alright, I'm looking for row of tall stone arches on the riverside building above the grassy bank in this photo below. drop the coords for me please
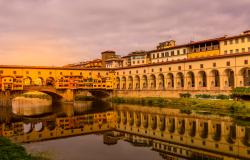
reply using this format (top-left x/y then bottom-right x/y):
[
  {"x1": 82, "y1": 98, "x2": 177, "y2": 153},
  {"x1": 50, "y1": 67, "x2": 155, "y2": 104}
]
[{"x1": 116, "y1": 68, "x2": 250, "y2": 90}]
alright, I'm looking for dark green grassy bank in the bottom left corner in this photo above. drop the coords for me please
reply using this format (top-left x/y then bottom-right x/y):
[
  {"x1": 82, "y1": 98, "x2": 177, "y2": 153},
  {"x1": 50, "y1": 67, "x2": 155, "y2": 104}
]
[{"x1": 0, "y1": 136, "x2": 50, "y2": 160}]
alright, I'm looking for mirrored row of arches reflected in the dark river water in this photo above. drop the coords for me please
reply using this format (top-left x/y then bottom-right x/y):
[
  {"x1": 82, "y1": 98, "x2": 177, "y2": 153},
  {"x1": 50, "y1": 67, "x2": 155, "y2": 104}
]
[{"x1": 116, "y1": 111, "x2": 250, "y2": 144}]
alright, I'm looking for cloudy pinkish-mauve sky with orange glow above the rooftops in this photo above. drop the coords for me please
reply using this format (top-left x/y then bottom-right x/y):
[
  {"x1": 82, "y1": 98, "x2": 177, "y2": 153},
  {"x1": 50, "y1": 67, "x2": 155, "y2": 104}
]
[{"x1": 0, "y1": 0, "x2": 250, "y2": 66}]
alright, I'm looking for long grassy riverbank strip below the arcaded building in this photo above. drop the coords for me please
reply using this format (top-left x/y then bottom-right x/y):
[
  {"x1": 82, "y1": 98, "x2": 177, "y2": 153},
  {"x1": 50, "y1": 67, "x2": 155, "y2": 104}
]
[{"x1": 109, "y1": 97, "x2": 250, "y2": 118}]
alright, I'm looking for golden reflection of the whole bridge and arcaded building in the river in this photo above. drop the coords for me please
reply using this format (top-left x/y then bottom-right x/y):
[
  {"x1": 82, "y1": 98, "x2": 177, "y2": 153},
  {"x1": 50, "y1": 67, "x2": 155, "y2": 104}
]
[{"x1": 0, "y1": 102, "x2": 250, "y2": 159}]
